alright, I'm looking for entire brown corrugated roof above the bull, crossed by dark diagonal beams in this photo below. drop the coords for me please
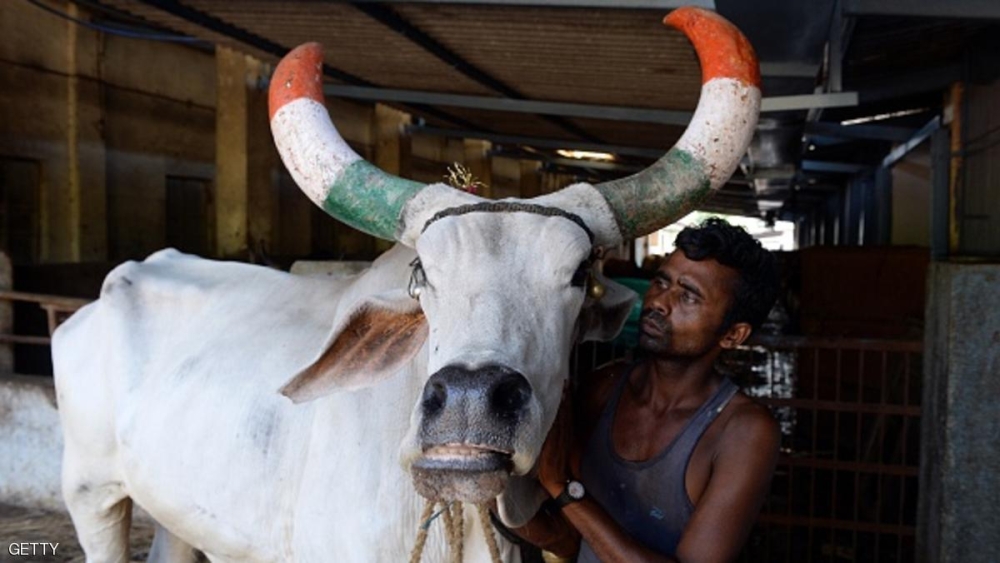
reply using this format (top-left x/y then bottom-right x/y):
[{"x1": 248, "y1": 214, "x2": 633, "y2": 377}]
[{"x1": 97, "y1": 0, "x2": 701, "y2": 138}]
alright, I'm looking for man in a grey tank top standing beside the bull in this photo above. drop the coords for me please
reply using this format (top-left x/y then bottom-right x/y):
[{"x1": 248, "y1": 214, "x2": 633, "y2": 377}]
[{"x1": 520, "y1": 219, "x2": 778, "y2": 562}]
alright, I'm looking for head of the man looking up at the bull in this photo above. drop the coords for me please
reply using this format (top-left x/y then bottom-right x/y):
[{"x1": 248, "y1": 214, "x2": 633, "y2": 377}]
[{"x1": 639, "y1": 218, "x2": 778, "y2": 357}]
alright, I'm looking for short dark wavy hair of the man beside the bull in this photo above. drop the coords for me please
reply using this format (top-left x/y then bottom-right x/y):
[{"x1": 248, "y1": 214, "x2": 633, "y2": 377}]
[{"x1": 677, "y1": 217, "x2": 778, "y2": 330}]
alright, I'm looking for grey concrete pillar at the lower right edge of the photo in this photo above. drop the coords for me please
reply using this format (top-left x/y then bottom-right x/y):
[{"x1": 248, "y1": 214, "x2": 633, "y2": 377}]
[{"x1": 916, "y1": 263, "x2": 1000, "y2": 563}]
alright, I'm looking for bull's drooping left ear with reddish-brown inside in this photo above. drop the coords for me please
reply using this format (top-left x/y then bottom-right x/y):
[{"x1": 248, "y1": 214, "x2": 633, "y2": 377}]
[{"x1": 281, "y1": 291, "x2": 427, "y2": 403}]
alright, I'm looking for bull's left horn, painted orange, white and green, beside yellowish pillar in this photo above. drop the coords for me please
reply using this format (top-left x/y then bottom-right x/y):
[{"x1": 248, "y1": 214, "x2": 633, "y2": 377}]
[{"x1": 268, "y1": 43, "x2": 424, "y2": 240}]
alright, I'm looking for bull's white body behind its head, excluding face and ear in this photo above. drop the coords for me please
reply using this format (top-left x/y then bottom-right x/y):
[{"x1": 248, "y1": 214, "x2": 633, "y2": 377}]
[{"x1": 49, "y1": 249, "x2": 524, "y2": 562}]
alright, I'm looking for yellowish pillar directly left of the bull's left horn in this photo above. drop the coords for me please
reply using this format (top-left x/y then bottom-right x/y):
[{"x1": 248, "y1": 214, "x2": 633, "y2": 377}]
[{"x1": 215, "y1": 46, "x2": 277, "y2": 258}]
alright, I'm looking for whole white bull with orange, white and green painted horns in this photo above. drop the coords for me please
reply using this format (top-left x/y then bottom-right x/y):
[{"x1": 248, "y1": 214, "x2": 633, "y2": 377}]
[{"x1": 53, "y1": 9, "x2": 760, "y2": 562}]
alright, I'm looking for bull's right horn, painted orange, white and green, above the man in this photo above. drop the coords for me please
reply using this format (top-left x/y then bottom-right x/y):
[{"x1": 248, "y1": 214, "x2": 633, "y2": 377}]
[{"x1": 594, "y1": 7, "x2": 760, "y2": 239}]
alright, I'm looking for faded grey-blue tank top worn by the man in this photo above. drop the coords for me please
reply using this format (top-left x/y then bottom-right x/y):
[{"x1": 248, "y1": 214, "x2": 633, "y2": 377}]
[{"x1": 577, "y1": 371, "x2": 739, "y2": 563}]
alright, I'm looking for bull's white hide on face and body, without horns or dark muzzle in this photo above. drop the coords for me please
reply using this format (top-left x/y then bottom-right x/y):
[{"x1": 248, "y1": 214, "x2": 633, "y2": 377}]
[{"x1": 53, "y1": 208, "x2": 634, "y2": 562}]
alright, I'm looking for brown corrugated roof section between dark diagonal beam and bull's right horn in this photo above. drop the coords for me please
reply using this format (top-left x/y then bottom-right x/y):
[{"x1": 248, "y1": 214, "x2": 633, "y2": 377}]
[{"x1": 395, "y1": 4, "x2": 701, "y2": 110}]
